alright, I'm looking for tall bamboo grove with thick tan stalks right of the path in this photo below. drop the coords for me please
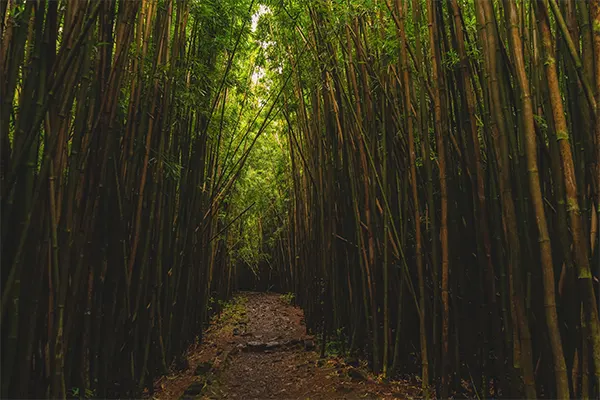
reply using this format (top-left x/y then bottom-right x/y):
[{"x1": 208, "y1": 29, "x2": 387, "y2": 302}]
[{"x1": 264, "y1": 0, "x2": 600, "y2": 398}]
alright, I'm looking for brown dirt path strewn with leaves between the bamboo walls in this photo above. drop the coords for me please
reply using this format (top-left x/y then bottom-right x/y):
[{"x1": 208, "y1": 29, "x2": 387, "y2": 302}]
[{"x1": 148, "y1": 292, "x2": 421, "y2": 400}]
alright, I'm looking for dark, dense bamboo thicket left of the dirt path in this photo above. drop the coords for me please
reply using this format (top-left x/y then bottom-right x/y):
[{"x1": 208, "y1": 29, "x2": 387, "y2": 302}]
[{"x1": 0, "y1": 0, "x2": 262, "y2": 398}]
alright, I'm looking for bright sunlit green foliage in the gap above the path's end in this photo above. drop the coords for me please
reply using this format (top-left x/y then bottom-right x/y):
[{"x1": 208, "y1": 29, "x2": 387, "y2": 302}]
[{"x1": 219, "y1": 5, "x2": 290, "y2": 275}]
